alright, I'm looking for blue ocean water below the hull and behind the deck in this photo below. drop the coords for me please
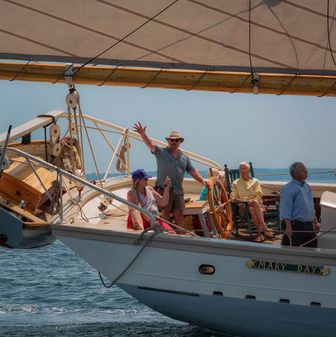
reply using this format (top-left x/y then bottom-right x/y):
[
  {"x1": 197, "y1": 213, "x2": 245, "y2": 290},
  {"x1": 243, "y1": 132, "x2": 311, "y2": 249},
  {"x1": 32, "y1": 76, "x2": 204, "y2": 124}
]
[{"x1": 0, "y1": 169, "x2": 336, "y2": 337}]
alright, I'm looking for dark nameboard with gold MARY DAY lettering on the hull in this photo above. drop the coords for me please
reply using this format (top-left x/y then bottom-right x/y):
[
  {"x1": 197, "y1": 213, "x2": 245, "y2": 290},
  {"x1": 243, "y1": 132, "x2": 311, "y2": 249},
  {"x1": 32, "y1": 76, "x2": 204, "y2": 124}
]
[{"x1": 246, "y1": 259, "x2": 330, "y2": 276}]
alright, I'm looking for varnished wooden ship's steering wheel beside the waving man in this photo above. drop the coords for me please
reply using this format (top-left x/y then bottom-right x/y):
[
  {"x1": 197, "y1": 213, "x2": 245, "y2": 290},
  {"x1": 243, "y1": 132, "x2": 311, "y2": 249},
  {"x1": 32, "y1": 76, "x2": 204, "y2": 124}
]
[{"x1": 208, "y1": 177, "x2": 232, "y2": 239}]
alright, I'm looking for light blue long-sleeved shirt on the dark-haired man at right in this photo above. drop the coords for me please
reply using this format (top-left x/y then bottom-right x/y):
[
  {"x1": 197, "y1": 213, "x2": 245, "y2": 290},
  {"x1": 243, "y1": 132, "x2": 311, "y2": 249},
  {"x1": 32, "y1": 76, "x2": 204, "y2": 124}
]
[{"x1": 280, "y1": 179, "x2": 315, "y2": 222}]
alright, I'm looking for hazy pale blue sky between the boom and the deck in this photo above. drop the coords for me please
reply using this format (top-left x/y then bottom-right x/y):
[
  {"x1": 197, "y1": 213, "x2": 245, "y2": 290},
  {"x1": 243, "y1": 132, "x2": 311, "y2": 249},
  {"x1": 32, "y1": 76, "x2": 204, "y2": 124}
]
[{"x1": 0, "y1": 81, "x2": 336, "y2": 170}]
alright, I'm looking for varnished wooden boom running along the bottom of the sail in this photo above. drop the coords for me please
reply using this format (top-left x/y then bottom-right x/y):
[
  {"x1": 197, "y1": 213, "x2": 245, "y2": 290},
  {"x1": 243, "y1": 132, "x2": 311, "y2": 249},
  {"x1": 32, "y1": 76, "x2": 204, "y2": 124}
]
[{"x1": 0, "y1": 62, "x2": 336, "y2": 96}]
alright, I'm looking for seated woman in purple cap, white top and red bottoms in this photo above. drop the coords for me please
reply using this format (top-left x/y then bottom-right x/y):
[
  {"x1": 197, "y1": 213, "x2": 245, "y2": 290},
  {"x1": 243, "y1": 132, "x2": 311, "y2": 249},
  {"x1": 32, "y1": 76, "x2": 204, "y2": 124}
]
[{"x1": 127, "y1": 169, "x2": 175, "y2": 233}]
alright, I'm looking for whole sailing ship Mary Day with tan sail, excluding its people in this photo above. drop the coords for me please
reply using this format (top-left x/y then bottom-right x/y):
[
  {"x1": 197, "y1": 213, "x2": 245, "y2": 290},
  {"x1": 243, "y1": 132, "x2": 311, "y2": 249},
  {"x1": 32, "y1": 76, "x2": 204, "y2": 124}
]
[{"x1": 0, "y1": 0, "x2": 336, "y2": 337}]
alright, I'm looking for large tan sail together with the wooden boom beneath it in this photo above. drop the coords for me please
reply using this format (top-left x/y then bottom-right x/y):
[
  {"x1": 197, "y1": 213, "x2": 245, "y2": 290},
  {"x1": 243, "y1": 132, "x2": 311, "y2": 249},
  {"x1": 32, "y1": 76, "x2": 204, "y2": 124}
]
[{"x1": 0, "y1": 0, "x2": 336, "y2": 96}]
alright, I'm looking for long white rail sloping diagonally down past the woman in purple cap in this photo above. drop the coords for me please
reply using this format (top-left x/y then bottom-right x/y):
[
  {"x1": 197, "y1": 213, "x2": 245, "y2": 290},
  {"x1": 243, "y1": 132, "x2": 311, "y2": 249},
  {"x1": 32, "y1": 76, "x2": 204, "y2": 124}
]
[{"x1": 0, "y1": 146, "x2": 160, "y2": 228}]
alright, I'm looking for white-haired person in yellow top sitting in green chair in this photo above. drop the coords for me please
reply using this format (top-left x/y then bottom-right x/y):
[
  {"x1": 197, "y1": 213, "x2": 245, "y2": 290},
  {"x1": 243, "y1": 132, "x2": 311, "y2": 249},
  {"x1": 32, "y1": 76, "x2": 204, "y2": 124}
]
[{"x1": 230, "y1": 162, "x2": 274, "y2": 242}]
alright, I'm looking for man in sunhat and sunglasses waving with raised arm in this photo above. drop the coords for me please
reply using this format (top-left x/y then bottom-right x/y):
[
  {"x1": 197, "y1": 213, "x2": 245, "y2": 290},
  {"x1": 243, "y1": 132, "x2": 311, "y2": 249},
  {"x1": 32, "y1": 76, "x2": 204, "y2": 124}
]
[{"x1": 134, "y1": 122, "x2": 209, "y2": 227}]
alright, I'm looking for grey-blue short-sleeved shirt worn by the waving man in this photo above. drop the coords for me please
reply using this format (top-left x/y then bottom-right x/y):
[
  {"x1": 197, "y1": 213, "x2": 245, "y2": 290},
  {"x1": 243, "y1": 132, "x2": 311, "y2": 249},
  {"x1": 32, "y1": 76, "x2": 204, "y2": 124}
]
[{"x1": 153, "y1": 145, "x2": 194, "y2": 195}]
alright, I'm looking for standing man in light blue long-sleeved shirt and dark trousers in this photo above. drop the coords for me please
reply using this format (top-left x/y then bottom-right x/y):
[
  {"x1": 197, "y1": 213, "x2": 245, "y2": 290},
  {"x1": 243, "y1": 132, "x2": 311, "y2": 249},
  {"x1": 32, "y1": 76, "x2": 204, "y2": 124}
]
[{"x1": 280, "y1": 162, "x2": 320, "y2": 248}]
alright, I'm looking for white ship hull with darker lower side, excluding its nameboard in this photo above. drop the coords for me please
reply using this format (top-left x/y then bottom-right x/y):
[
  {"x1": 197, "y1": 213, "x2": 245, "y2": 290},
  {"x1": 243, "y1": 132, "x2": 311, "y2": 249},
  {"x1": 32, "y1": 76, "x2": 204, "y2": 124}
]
[{"x1": 53, "y1": 226, "x2": 336, "y2": 337}]
